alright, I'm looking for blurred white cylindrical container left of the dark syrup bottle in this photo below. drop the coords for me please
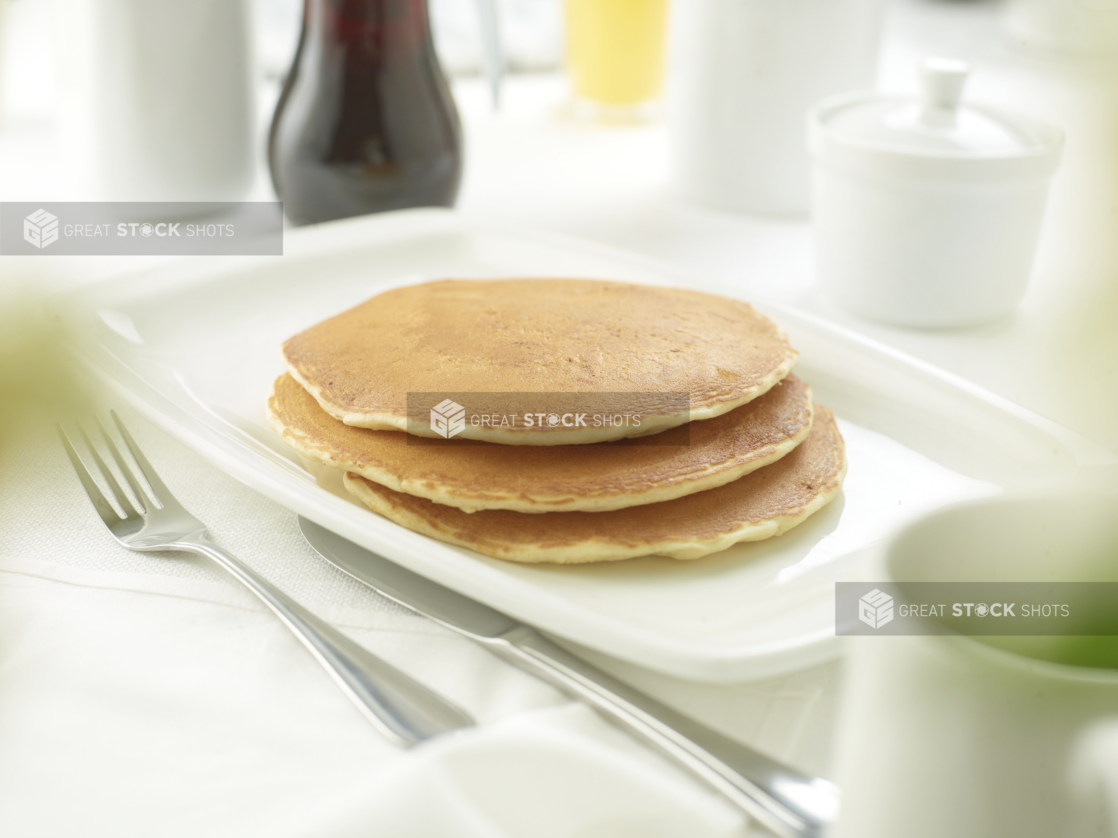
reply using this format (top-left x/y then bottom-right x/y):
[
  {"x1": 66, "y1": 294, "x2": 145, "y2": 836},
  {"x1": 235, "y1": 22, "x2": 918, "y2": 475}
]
[{"x1": 55, "y1": 0, "x2": 259, "y2": 211}]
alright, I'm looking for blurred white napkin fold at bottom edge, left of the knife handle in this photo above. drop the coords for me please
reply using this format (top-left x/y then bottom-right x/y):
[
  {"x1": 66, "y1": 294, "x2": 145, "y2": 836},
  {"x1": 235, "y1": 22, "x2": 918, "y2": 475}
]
[{"x1": 274, "y1": 704, "x2": 745, "y2": 838}]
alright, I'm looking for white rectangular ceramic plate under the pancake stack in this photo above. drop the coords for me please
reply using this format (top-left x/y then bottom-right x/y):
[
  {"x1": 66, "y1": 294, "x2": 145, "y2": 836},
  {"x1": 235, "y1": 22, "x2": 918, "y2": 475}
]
[{"x1": 61, "y1": 210, "x2": 1107, "y2": 682}]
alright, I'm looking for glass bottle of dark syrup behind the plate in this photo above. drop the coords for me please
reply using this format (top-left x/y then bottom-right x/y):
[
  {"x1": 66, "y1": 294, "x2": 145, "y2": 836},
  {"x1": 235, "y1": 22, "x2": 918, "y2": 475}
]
[{"x1": 268, "y1": 0, "x2": 463, "y2": 225}]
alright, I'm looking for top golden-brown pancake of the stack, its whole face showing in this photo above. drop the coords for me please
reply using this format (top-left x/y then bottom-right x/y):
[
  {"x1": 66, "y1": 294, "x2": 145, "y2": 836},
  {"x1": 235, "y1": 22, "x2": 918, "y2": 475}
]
[{"x1": 283, "y1": 279, "x2": 796, "y2": 446}]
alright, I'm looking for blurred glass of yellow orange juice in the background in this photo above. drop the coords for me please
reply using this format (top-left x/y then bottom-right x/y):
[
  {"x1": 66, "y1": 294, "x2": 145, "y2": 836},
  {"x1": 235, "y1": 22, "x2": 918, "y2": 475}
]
[{"x1": 566, "y1": 0, "x2": 666, "y2": 120}]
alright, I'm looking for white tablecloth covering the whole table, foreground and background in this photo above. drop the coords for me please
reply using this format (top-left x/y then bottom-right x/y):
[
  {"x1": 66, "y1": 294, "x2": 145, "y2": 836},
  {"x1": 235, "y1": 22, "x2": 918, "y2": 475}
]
[{"x1": 0, "y1": 0, "x2": 1118, "y2": 837}]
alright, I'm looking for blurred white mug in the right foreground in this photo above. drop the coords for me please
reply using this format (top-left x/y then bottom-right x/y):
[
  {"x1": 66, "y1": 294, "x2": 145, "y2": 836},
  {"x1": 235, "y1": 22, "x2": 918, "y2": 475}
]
[{"x1": 836, "y1": 478, "x2": 1118, "y2": 838}]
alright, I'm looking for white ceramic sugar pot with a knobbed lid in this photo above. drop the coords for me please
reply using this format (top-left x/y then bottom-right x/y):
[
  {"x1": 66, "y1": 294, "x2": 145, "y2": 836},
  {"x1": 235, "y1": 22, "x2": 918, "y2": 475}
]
[{"x1": 808, "y1": 58, "x2": 1063, "y2": 327}]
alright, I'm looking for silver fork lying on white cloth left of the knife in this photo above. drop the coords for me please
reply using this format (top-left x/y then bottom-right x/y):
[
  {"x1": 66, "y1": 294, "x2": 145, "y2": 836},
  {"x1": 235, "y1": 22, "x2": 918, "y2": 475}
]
[{"x1": 58, "y1": 411, "x2": 474, "y2": 746}]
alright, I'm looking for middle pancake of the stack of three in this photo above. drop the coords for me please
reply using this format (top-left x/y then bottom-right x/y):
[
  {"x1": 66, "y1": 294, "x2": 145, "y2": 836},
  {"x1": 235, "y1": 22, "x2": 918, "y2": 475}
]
[{"x1": 268, "y1": 374, "x2": 812, "y2": 513}]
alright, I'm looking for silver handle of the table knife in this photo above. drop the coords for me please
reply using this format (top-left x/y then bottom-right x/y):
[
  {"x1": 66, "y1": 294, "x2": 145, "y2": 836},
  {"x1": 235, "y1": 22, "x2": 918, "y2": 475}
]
[{"x1": 485, "y1": 626, "x2": 839, "y2": 838}]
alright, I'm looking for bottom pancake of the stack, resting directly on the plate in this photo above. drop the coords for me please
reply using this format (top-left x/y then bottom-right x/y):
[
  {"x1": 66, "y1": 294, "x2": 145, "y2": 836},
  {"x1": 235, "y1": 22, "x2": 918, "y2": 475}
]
[{"x1": 343, "y1": 406, "x2": 846, "y2": 564}]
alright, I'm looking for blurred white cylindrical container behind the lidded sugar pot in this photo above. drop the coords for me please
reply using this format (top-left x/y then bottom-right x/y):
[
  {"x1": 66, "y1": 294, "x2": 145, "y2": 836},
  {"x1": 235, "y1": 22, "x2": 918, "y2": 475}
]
[{"x1": 666, "y1": 0, "x2": 881, "y2": 215}]
